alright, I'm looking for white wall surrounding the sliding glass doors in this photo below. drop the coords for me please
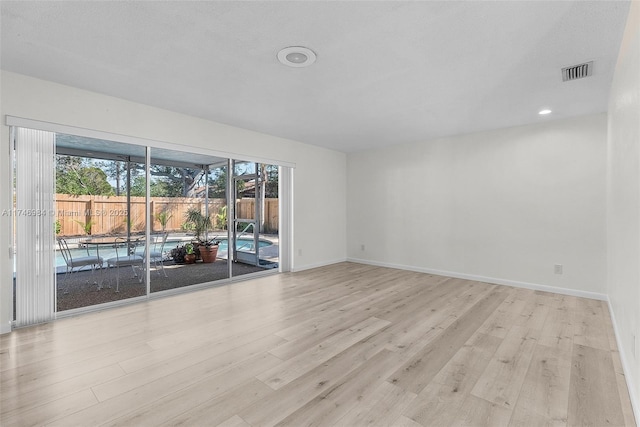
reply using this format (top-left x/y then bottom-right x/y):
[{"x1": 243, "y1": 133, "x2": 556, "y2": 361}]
[{"x1": 0, "y1": 71, "x2": 346, "y2": 332}]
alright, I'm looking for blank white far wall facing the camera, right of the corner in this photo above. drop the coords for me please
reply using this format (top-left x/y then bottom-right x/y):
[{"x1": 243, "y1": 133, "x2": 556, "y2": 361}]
[{"x1": 347, "y1": 114, "x2": 607, "y2": 298}]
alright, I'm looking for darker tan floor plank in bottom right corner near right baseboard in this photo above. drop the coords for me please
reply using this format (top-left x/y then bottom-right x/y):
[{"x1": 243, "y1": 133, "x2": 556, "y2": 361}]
[{"x1": 568, "y1": 344, "x2": 625, "y2": 426}]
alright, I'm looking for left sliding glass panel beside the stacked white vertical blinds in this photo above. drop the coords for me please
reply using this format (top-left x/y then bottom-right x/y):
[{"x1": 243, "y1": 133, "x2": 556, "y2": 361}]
[{"x1": 55, "y1": 134, "x2": 147, "y2": 312}]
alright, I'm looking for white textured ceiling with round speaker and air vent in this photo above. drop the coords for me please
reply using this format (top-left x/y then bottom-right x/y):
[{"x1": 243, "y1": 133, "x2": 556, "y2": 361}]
[{"x1": 0, "y1": 0, "x2": 629, "y2": 152}]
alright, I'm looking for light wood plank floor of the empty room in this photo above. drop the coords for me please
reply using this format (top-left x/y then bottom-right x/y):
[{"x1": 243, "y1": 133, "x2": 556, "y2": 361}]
[{"x1": 0, "y1": 263, "x2": 635, "y2": 427}]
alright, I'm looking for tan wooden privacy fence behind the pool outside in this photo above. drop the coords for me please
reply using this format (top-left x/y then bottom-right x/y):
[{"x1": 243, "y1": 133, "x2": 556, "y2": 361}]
[{"x1": 56, "y1": 194, "x2": 278, "y2": 236}]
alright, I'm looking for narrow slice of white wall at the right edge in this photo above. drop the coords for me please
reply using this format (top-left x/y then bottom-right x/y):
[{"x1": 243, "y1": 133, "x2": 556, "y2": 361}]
[{"x1": 607, "y1": 2, "x2": 640, "y2": 414}]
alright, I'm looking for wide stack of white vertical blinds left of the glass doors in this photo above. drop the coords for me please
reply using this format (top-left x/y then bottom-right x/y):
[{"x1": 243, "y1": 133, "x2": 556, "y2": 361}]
[{"x1": 13, "y1": 128, "x2": 56, "y2": 326}]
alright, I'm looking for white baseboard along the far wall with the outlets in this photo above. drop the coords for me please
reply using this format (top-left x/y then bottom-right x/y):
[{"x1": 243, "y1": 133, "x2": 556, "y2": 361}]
[{"x1": 347, "y1": 258, "x2": 608, "y2": 301}]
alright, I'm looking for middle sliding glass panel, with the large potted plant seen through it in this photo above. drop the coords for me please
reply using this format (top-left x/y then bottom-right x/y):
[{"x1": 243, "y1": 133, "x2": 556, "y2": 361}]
[{"x1": 149, "y1": 148, "x2": 230, "y2": 293}]
